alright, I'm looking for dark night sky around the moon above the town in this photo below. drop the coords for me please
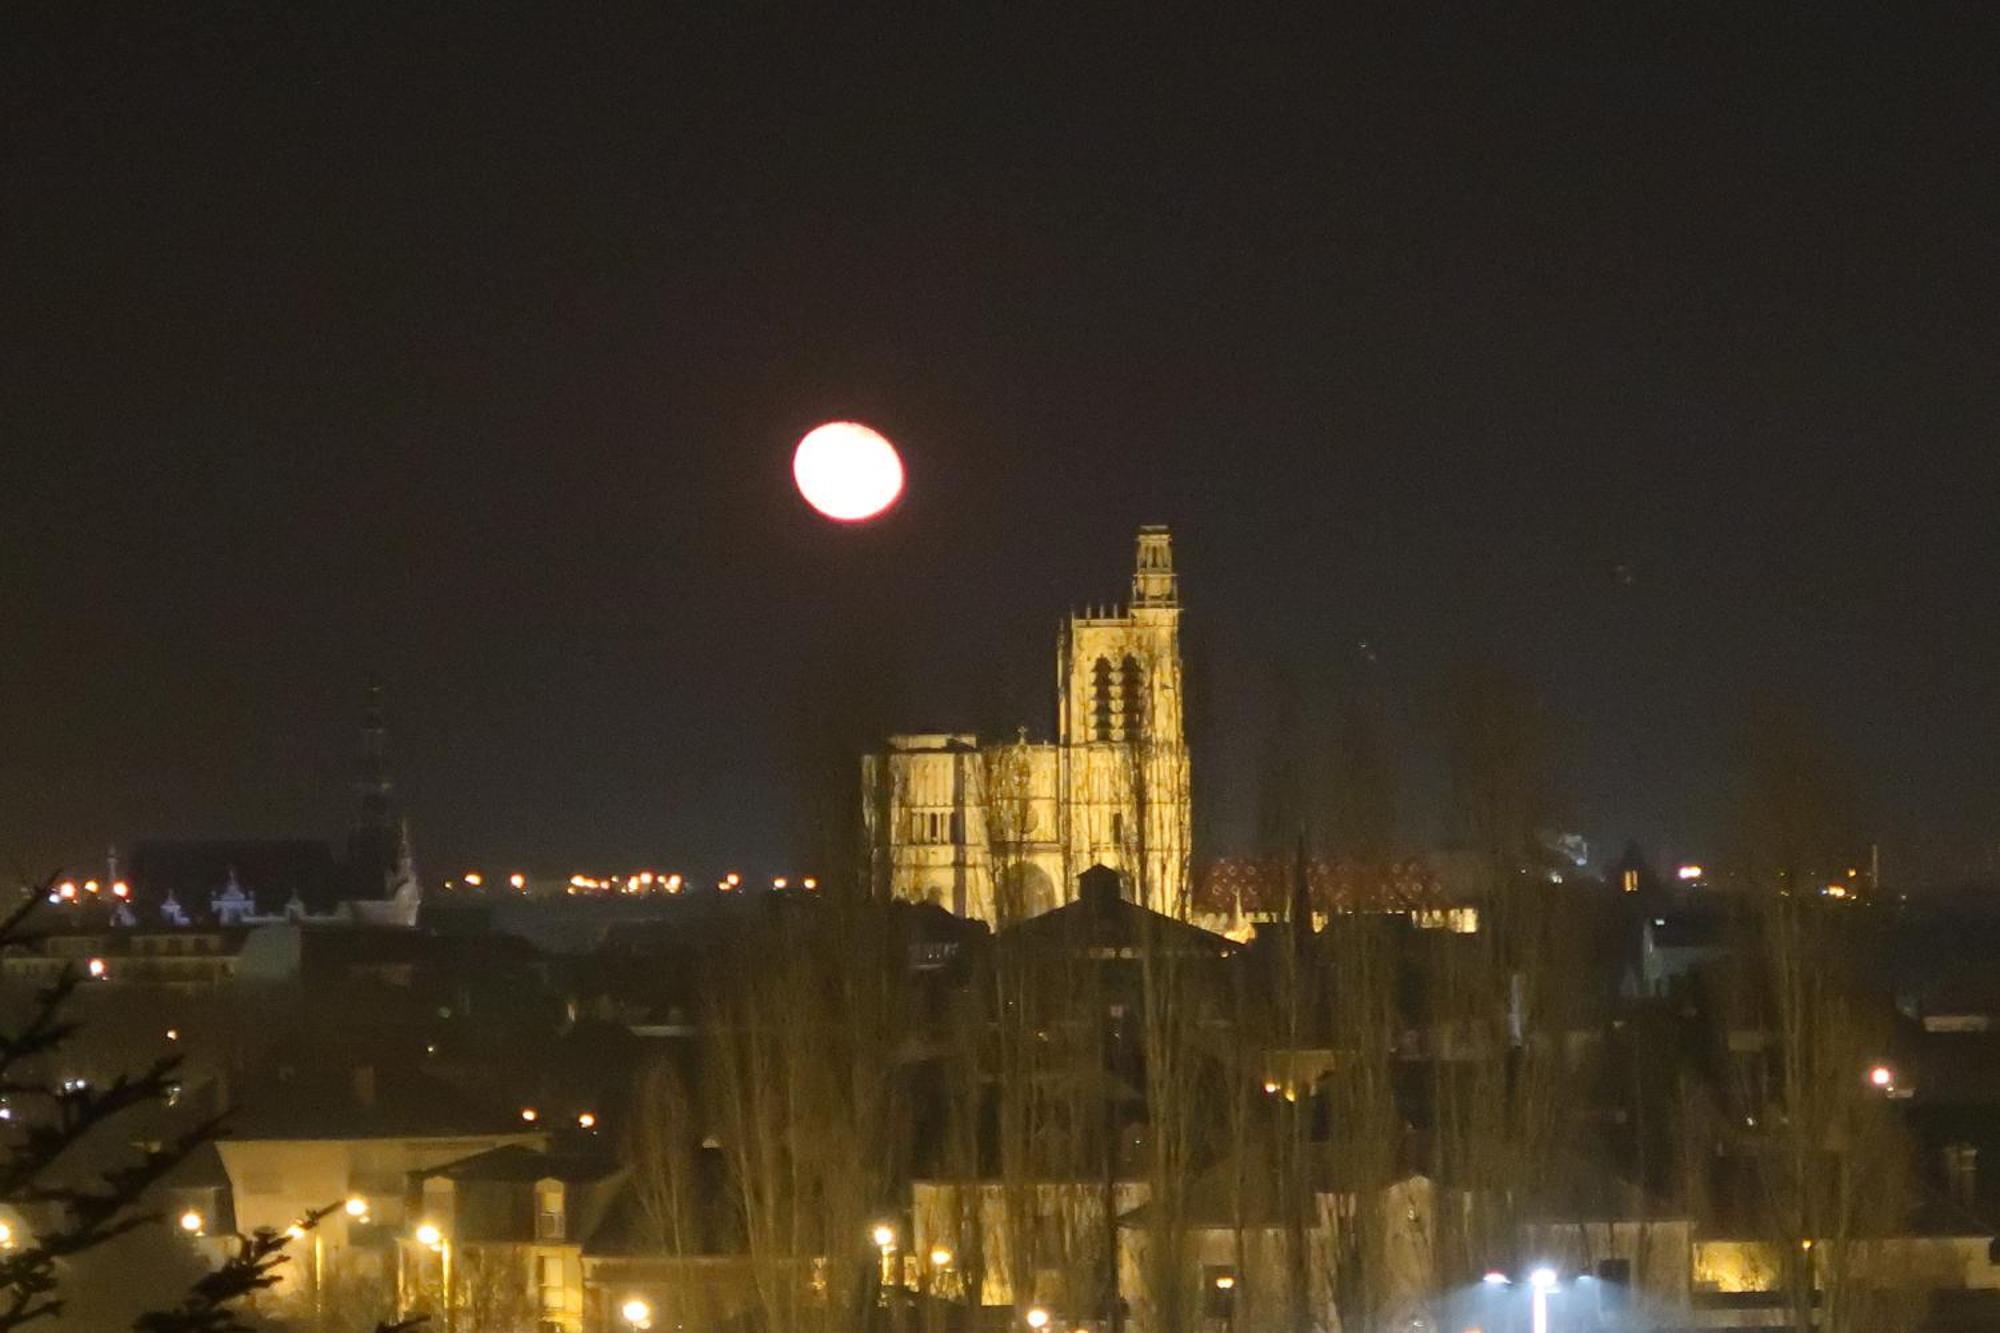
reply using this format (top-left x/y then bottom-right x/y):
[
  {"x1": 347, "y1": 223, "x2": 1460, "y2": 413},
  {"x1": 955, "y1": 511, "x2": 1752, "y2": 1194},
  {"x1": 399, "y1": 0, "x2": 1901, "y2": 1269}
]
[{"x1": 0, "y1": 4, "x2": 2000, "y2": 873}]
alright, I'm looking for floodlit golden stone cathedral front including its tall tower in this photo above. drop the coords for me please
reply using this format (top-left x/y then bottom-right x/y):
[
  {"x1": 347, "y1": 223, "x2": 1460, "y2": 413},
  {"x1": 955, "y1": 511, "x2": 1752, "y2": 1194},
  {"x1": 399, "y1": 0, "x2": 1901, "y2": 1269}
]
[{"x1": 862, "y1": 526, "x2": 1192, "y2": 925}]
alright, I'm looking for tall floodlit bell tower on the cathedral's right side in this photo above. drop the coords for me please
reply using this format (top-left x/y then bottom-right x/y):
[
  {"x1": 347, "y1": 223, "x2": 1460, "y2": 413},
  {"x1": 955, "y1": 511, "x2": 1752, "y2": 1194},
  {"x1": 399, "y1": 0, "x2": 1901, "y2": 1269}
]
[{"x1": 1056, "y1": 526, "x2": 1192, "y2": 917}]
